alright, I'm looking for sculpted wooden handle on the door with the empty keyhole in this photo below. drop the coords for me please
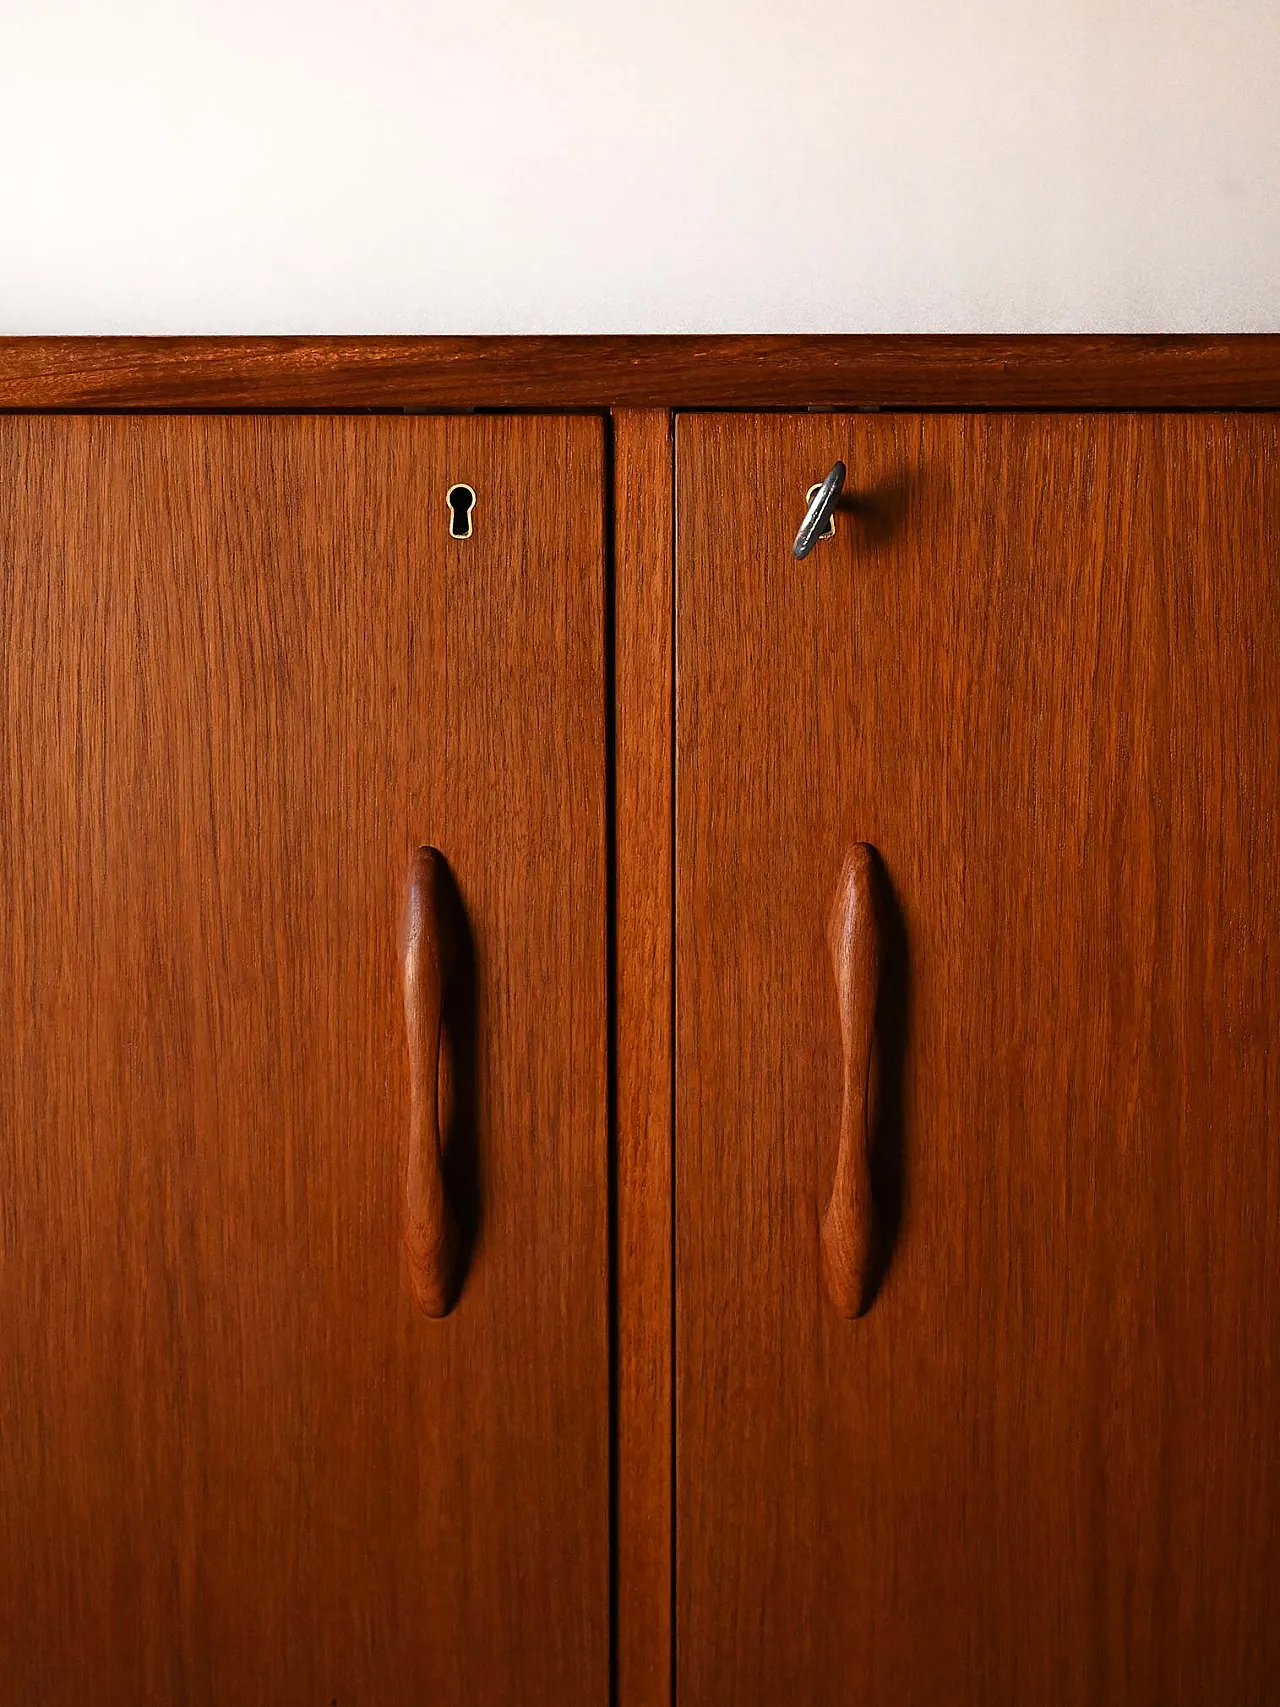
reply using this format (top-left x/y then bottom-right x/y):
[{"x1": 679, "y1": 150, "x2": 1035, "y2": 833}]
[{"x1": 404, "y1": 848, "x2": 459, "y2": 1316}]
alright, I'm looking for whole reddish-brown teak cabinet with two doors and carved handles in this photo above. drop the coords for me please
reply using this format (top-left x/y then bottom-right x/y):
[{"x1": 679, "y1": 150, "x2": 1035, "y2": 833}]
[{"x1": 0, "y1": 340, "x2": 1280, "y2": 1707}]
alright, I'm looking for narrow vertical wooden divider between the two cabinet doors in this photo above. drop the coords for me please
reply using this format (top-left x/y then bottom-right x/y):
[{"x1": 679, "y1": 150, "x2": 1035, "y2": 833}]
[{"x1": 613, "y1": 410, "x2": 672, "y2": 1707}]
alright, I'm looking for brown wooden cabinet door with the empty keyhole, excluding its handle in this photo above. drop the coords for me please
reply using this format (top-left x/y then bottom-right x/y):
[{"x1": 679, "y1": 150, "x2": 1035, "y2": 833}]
[{"x1": 0, "y1": 417, "x2": 609, "y2": 1707}]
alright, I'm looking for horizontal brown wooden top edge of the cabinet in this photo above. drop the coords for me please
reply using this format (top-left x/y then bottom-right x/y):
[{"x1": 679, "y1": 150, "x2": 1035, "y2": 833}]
[{"x1": 0, "y1": 333, "x2": 1280, "y2": 410}]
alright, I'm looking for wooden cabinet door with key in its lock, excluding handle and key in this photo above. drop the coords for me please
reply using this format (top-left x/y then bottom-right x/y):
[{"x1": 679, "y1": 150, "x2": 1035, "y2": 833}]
[{"x1": 676, "y1": 415, "x2": 1280, "y2": 1707}]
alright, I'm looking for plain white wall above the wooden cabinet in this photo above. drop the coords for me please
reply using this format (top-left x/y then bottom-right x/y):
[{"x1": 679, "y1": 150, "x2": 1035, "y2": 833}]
[{"x1": 0, "y1": 0, "x2": 1280, "y2": 333}]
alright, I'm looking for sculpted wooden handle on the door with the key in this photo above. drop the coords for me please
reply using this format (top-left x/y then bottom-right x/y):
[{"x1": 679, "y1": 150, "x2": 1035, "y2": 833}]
[{"x1": 823, "y1": 842, "x2": 884, "y2": 1316}]
